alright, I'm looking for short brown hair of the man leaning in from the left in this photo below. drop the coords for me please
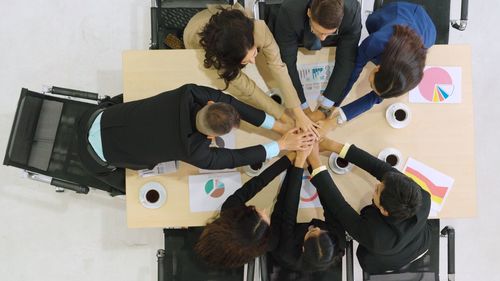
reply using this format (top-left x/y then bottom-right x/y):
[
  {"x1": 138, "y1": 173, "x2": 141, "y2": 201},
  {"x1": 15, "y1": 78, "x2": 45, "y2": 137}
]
[{"x1": 203, "y1": 102, "x2": 241, "y2": 135}]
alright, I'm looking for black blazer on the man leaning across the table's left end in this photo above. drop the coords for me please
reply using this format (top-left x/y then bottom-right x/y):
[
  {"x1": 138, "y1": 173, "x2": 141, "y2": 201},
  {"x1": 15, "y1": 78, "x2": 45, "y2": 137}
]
[{"x1": 101, "y1": 84, "x2": 266, "y2": 169}]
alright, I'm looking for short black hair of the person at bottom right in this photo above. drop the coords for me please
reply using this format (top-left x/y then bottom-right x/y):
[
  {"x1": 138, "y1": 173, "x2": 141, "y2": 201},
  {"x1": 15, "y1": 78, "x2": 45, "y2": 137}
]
[{"x1": 380, "y1": 172, "x2": 422, "y2": 220}]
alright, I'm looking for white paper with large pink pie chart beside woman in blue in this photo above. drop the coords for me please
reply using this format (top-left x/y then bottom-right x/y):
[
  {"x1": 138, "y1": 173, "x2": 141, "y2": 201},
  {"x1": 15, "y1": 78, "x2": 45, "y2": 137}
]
[{"x1": 410, "y1": 66, "x2": 462, "y2": 103}]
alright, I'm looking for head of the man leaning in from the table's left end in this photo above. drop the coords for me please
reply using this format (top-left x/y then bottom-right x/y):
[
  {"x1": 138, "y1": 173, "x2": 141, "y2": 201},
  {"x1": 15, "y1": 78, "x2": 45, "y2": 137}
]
[{"x1": 196, "y1": 102, "x2": 240, "y2": 137}]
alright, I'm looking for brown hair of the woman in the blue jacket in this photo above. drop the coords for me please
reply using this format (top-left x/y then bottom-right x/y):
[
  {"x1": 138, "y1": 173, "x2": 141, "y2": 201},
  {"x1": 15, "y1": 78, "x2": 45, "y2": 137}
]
[{"x1": 374, "y1": 25, "x2": 427, "y2": 98}]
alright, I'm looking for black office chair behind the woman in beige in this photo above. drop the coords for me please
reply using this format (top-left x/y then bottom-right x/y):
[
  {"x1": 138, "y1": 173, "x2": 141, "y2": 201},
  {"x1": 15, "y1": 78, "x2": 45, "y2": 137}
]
[{"x1": 149, "y1": 0, "x2": 244, "y2": 50}]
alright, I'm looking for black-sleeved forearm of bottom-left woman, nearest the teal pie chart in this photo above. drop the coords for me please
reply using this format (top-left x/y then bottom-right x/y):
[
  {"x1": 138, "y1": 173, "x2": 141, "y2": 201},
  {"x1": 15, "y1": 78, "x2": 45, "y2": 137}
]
[{"x1": 222, "y1": 156, "x2": 290, "y2": 210}]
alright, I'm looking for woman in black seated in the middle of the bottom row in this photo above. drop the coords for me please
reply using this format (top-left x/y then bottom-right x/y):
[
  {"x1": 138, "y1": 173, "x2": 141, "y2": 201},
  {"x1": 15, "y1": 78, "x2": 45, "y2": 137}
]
[{"x1": 270, "y1": 145, "x2": 346, "y2": 280}]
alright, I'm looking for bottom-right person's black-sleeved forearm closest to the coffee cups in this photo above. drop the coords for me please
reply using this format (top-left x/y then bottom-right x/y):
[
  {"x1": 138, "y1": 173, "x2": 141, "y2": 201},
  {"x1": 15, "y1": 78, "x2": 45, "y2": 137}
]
[{"x1": 345, "y1": 145, "x2": 399, "y2": 181}]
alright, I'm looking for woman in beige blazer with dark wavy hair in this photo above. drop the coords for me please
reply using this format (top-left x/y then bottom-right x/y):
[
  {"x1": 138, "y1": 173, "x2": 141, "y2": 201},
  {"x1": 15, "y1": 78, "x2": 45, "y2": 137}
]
[{"x1": 184, "y1": 4, "x2": 319, "y2": 136}]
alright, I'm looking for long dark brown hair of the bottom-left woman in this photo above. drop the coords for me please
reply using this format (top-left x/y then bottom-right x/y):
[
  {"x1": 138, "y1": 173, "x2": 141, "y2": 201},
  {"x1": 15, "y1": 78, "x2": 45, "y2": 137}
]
[{"x1": 195, "y1": 203, "x2": 270, "y2": 268}]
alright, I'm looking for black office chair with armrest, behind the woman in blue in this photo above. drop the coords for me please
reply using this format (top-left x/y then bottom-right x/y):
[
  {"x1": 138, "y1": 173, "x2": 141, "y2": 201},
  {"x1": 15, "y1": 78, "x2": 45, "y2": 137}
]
[{"x1": 373, "y1": 0, "x2": 469, "y2": 44}]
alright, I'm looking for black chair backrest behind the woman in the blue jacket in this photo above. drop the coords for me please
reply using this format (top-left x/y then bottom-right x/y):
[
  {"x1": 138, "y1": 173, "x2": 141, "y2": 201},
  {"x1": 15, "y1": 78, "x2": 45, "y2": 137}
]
[{"x1": 373, "y1": 0, "x2": 451, "y2": 44}]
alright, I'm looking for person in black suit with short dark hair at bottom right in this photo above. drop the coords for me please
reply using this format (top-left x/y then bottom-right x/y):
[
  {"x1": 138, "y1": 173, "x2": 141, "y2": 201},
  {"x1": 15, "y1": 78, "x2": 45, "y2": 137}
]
[{"x1": 308, "y1": 140, "x2": 431, "y2": 273}]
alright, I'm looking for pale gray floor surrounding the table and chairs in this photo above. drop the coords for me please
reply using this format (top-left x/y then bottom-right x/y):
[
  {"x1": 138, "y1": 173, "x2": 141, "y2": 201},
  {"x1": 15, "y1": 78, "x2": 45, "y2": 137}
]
[{"x1": 0, "y1": 0, "x2": 500, "y2": 281}]
